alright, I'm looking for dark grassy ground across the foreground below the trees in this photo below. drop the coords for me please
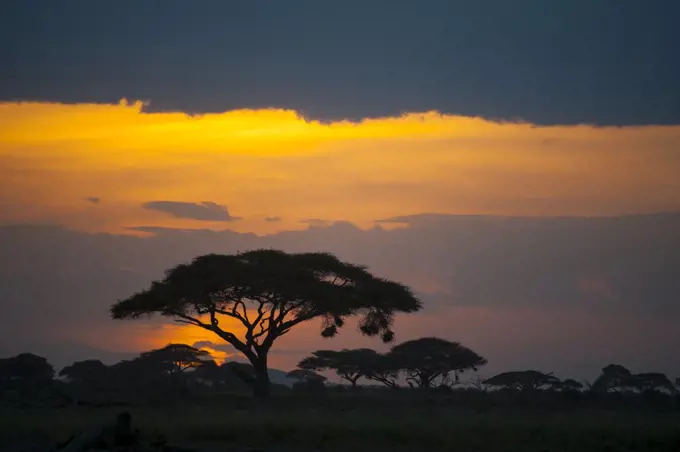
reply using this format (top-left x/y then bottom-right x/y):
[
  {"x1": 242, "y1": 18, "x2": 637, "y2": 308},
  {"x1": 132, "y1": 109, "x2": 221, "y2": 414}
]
[{"x1": 0, "y1": 399, "x2": 680, "y2": 452}]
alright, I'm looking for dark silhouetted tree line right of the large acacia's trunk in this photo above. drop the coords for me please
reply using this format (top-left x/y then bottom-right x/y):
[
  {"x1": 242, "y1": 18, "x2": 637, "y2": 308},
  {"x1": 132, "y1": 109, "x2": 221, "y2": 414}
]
[{"x1": 298, "y1": 337, "x2": 680, "y2": 394}]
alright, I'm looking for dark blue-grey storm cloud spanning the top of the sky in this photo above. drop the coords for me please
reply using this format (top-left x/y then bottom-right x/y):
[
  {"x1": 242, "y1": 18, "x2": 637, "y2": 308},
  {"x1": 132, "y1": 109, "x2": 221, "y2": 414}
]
[{"x1": 0, "y1": 0, "x2": 680, "y2": 124}]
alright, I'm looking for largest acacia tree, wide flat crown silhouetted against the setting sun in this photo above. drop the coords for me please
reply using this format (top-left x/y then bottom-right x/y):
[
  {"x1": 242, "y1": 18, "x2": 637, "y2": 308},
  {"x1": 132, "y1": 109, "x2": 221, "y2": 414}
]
[{"x1": 111, "y1": 250, "x2": 421, "y2": 398}]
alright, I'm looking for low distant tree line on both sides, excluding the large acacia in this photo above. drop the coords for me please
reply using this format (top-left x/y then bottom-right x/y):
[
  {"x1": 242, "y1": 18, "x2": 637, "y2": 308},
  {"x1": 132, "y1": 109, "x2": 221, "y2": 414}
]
[{"x1": 0, "y1": 337, "x2": 680, "y2": 406}]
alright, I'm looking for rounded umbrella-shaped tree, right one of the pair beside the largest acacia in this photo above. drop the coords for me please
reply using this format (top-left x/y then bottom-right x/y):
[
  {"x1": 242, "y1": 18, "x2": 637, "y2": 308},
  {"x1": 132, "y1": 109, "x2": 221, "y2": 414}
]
[{"x1": 388, "y1": 337, "x2": 486, "y2": 388}]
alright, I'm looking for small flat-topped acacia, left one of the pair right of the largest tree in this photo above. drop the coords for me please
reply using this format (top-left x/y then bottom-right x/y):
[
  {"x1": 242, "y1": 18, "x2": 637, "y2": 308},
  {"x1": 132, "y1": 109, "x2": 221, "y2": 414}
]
[{"x1": 298, "y1": 348, "x2": 378, "y2": 388}]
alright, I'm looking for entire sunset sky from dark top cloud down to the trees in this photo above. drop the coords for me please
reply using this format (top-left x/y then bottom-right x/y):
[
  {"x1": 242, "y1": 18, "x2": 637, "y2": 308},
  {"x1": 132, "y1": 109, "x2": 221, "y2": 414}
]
[{"x1": 0, "y1": 0, "x2": 680, "y2": 379}]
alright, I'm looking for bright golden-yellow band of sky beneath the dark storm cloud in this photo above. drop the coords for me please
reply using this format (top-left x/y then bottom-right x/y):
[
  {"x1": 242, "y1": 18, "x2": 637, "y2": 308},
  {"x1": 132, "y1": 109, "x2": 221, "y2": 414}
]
[{"x1": 0, "y1": 102, "x2": 680, "y2": 233}]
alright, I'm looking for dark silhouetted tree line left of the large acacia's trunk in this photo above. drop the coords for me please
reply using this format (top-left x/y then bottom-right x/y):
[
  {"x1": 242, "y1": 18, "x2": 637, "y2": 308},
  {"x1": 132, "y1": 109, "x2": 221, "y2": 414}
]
[{"x1": 0, "y1": 344, "x2": 260, "y2": 405}]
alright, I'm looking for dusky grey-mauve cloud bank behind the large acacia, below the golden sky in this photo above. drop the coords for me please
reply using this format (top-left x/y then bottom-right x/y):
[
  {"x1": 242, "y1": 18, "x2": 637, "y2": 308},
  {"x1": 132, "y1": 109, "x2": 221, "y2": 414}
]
[{"x1": 0, "y1": 213, "x2": 680, "y2": 378}]
